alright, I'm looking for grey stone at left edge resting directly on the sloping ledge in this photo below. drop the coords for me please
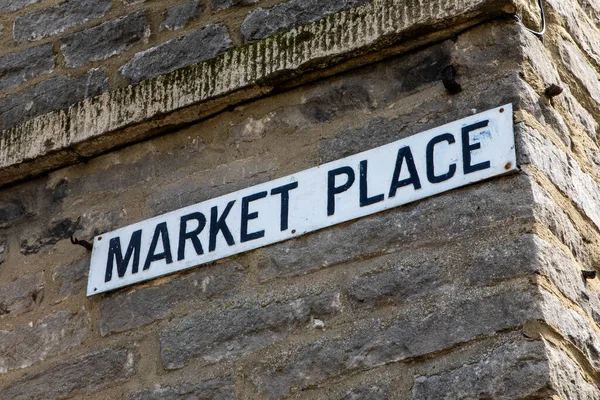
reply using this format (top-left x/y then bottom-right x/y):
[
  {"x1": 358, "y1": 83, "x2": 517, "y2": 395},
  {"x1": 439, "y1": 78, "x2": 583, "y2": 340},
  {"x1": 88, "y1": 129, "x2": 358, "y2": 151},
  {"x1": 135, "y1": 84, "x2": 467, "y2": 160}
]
[{"x1": 0, "y1": 69, "x2": 108, "y2": 130}]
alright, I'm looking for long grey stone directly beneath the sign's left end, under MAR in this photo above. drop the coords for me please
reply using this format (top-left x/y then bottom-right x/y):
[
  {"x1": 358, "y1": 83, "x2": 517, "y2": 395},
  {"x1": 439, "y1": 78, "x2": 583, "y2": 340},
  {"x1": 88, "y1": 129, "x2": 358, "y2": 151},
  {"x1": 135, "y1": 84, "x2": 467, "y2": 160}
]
[{"x1": 100, "y1": 262, "x2": 245, "y2": 335}]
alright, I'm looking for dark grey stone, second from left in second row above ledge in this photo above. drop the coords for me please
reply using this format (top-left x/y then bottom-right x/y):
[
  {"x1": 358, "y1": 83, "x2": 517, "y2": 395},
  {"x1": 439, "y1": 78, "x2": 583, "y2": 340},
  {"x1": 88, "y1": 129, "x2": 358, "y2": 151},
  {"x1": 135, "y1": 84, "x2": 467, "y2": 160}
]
[{"x1": 61, "y1": 11, "x2": 150, "y2": 67}]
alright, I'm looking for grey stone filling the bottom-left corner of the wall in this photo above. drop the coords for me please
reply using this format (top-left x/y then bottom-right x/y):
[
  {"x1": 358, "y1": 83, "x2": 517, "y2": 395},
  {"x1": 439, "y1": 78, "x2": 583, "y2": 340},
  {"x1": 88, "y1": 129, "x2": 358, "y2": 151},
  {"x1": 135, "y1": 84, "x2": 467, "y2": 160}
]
[{"x1": 2, "y1": 349, "x2": 136, "y2": 400}]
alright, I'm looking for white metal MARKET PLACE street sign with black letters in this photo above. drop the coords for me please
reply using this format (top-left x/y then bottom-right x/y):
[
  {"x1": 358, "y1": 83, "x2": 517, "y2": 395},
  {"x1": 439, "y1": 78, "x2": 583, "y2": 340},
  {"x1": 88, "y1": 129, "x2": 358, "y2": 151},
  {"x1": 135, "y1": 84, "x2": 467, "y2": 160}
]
[{"x1": 87, "y1": 104, "x2": 516, "y2": 296}]
